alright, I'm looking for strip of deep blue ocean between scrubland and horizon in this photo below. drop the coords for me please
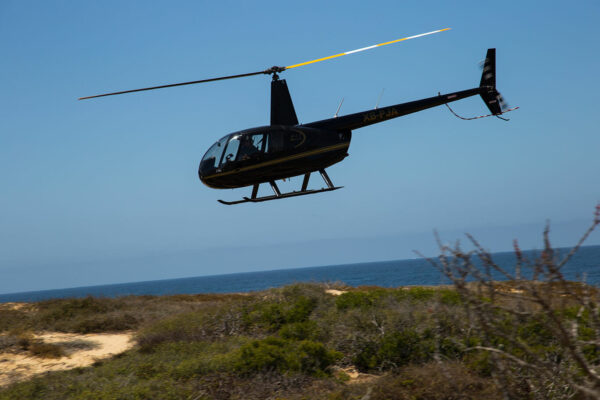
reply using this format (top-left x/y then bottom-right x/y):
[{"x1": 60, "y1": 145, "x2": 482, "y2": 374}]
[{"x1": 0, "y1": 246, "x2": 600, "y2": 303}]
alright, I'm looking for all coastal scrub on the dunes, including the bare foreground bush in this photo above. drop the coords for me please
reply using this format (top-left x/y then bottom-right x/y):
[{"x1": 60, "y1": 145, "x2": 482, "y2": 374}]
[{"x1": 0, "y1": 208, "x2": 600, "y2": 400}]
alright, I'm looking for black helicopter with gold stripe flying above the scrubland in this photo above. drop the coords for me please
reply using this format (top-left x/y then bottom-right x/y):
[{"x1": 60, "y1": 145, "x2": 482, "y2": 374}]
[{"x1": 79, "y1": 28, "x2": 518, "y2": 205}]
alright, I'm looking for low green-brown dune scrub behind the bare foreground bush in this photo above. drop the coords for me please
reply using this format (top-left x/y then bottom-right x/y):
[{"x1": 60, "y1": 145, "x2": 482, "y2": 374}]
[{"x1": 0, "y1": 284, "x2": 599, "y2": 400}]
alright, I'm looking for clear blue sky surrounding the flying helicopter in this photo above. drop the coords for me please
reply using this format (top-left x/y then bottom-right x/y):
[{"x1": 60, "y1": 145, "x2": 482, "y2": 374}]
[{"x1": 0, "y1": 0, "x2": 600, "y2": 293}]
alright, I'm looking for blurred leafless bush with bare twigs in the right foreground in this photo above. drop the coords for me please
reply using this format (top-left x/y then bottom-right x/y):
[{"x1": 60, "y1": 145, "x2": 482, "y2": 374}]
[{"x1": 422, "y1": 204, "x2": 600, "y2": 399}]
